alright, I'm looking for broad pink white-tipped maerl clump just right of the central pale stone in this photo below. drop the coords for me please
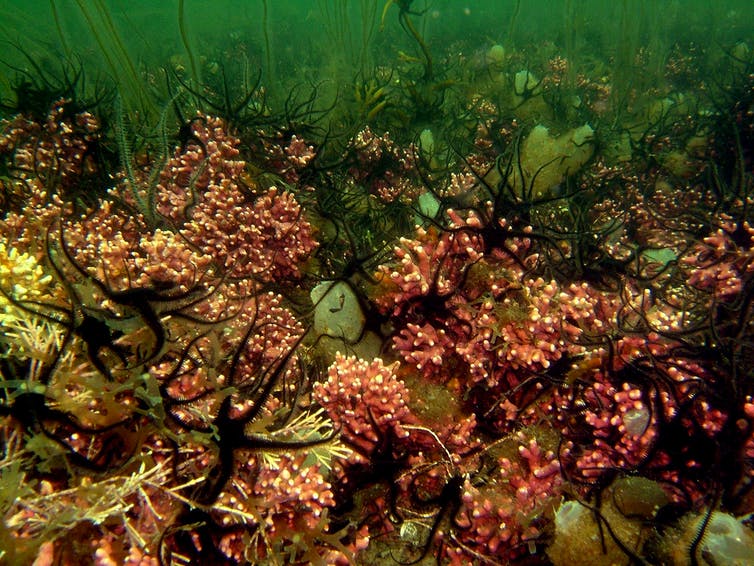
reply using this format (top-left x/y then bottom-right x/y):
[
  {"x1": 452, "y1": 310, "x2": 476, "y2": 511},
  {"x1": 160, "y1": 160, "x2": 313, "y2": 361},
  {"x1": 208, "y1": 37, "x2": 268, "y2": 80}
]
[{"x1": 377, "y1": 206, "x2": 609, "y2": 406}]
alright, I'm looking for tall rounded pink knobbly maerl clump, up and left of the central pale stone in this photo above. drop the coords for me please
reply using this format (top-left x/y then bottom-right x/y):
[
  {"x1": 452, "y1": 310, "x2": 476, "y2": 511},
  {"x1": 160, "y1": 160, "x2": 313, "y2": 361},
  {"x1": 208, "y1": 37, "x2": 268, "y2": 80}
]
[{"x1": 154, "y1": 117, "x2": 317, "y2": 281}]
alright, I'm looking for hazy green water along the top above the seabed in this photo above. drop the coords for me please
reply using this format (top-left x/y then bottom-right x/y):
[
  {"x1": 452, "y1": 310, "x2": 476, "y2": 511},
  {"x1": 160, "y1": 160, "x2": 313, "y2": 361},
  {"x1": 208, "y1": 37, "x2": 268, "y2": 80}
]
[{"x1": 0, "y1": 0, "x2": 754, "y2": 113}]
